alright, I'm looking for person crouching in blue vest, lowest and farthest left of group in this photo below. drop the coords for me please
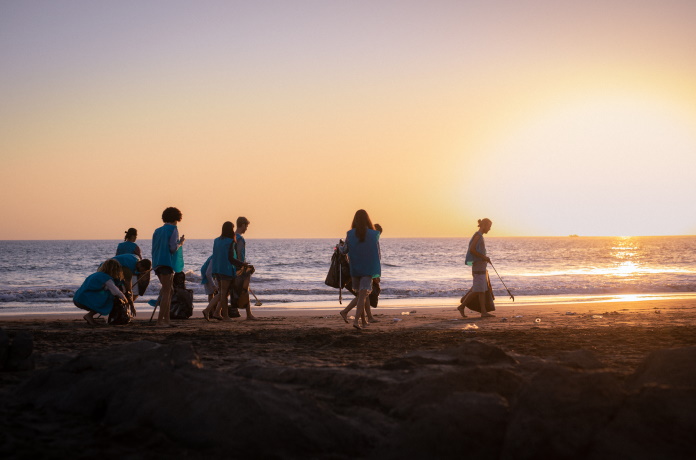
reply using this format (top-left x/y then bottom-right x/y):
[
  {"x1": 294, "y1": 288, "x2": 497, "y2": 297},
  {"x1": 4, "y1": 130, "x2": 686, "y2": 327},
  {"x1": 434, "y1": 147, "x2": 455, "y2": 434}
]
[{"x1": 73, "y1": 259, "x2": 128, "y2": 326}]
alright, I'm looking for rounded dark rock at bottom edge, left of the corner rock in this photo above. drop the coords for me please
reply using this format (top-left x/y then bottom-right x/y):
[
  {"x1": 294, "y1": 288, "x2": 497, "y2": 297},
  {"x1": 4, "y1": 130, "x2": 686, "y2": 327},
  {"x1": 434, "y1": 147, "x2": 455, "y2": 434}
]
[{"x1": 502, "y1": 365, "x2": 625, "y2": 459}]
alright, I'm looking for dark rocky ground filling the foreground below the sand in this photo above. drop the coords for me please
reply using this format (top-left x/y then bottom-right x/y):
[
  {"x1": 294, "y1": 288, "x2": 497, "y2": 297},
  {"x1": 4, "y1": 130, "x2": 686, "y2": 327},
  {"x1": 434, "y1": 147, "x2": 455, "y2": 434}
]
[{"x1": 0, "y1": 320, "x2": 696, "y2": 459}]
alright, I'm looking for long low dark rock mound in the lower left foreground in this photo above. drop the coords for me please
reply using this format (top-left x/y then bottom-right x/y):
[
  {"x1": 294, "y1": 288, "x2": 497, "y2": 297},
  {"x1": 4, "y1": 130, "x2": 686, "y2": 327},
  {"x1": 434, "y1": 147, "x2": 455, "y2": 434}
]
[{"x1": 17, "y1": 342, "x2": 374, "y2": 458}]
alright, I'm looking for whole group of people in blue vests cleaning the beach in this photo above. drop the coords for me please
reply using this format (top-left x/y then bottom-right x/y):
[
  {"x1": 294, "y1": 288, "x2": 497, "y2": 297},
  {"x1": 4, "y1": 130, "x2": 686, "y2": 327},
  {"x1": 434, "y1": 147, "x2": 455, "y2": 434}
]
[{"x1": 73, "y1": 207, "x2": 493, "y2": 329}]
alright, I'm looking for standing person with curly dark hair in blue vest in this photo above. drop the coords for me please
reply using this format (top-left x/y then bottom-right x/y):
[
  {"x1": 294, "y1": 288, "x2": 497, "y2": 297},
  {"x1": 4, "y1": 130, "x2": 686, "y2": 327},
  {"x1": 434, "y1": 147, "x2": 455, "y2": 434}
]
[{"x1": 152, "y1": 207, "x2": 186, "y2": 327}]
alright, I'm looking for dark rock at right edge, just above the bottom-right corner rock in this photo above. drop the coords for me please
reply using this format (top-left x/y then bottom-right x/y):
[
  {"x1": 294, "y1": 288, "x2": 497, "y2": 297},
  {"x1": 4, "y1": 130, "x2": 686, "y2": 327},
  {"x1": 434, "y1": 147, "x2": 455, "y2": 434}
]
[{"x1": 629, "y1": 347, "x2": 696, "y2": 390}]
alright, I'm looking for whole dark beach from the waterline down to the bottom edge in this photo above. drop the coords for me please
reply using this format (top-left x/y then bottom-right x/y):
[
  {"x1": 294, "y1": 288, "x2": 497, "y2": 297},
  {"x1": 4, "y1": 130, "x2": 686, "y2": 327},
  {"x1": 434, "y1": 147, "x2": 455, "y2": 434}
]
[{"x1": 0, "y1": 297, "x2": 696, "y2": 458}]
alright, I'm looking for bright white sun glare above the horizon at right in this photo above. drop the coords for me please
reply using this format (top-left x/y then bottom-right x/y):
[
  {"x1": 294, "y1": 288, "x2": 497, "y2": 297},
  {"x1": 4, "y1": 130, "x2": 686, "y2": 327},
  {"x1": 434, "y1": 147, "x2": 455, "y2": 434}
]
[{"x1": 463, "y1": 96, "x2": 696, "y2": 237}]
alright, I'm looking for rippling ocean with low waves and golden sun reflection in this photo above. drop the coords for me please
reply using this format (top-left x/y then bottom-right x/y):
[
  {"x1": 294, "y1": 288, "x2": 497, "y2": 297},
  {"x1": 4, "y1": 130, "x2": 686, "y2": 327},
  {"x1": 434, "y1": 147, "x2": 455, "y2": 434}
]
[{"x1": 0, "y1": 236, "x2": 696, "y2": 314}]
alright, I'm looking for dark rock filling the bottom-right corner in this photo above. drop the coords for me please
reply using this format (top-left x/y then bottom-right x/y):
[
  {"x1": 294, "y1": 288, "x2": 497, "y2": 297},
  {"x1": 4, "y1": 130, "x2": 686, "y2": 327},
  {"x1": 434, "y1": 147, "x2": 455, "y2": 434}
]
[{"x1": 589, "y1": 386, "x2": 696, "y2": 460}]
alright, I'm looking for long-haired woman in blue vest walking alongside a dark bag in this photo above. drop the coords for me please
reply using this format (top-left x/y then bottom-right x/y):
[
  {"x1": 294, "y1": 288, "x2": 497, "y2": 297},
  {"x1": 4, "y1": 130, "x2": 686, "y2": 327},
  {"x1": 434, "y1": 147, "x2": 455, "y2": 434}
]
[{"x1": 341, "y1": 209, "x2": 382, "y2": 329}]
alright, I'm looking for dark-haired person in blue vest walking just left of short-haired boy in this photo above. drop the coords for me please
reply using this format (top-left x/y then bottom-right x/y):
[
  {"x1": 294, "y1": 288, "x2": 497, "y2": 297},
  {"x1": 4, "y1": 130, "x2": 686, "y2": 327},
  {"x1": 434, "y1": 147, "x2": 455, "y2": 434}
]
[{"x1": 203, "y1": 221, "x2": 247, "y2": 321}]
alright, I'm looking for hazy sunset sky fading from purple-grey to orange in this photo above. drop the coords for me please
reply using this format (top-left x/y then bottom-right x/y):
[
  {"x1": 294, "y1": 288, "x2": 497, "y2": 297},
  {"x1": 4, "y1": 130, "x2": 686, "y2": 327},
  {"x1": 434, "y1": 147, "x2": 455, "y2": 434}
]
[{"x1": 0, "y1": 0, "x2": 696, "y2": 239}]
